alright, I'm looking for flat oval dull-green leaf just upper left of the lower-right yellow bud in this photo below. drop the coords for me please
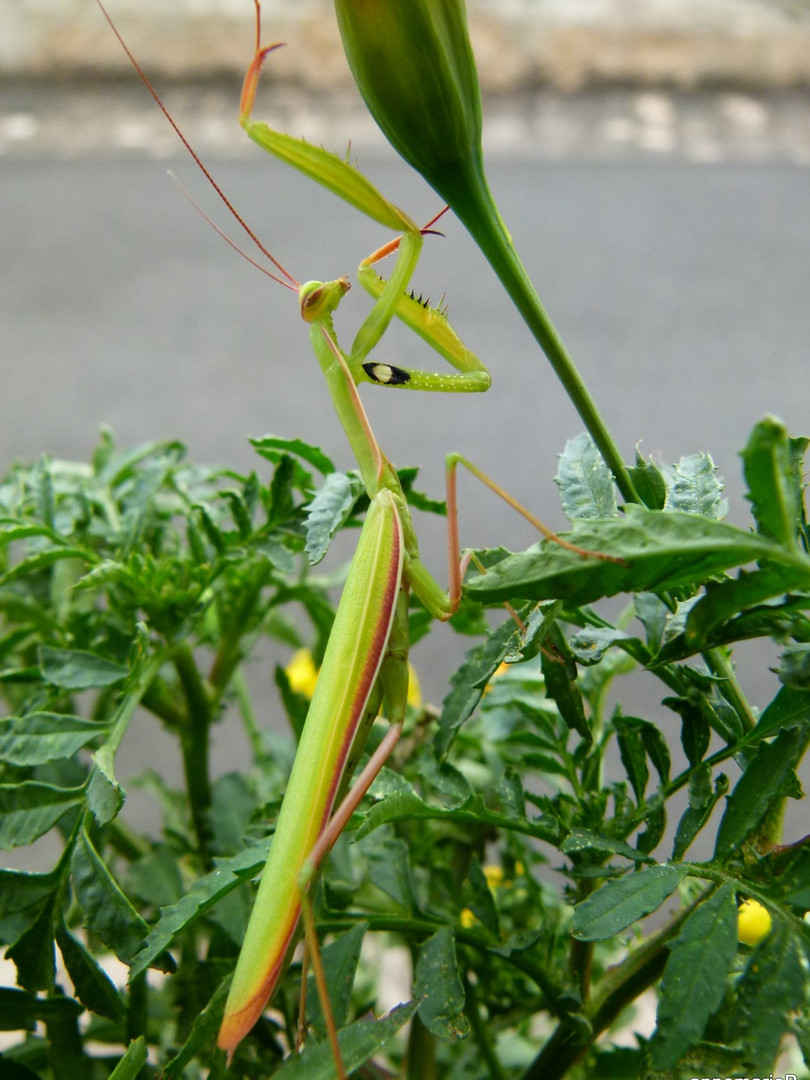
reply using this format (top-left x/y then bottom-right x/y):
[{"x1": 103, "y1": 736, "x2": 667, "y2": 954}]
[{"x1": 571, "y1": 863, "x2": 687, "y2": 942}]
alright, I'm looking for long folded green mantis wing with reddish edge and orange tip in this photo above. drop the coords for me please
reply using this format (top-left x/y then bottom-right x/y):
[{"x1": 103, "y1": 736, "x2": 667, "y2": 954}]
[{"x1": 218, "y1": 489, "x2": 405, "y2": 1052}]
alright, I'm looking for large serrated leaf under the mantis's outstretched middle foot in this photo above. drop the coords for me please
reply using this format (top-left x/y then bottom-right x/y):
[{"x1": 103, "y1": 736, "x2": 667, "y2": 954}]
[{"x1": 464, "y1": 504, "x2": 810, "y2": 605}]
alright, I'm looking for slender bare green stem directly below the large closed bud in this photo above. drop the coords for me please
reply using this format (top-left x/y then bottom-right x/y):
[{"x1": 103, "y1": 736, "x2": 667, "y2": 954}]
[{"x1": 451, "y1": 168, "x2": 640, "y2": 502}]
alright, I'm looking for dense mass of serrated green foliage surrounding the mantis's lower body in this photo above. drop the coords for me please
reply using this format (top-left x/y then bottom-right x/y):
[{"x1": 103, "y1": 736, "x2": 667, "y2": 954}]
[{"x1": 0, "y1": 419, "x2": 810, "y2": 1080}]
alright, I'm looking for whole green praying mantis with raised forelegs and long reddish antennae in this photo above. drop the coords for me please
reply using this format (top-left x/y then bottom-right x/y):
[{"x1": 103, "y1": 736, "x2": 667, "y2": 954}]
[{"x1": 98, "y1": 0, "x2": 609, "y2": 1078}]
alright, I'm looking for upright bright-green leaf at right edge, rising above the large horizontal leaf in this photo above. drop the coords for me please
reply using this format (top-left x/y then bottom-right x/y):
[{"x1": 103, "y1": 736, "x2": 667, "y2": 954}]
[{"x1": 742, "y1": 417, "x2": 801, "y2": 548}]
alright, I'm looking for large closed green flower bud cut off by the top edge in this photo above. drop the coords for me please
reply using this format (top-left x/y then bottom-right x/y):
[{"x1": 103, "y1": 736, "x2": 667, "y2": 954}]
[{"x1": 335, "y1": 0, "x2": 483, "y2": 205}]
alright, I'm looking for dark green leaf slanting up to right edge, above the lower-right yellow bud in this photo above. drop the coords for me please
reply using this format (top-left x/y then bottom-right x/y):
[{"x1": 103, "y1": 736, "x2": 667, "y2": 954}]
[{"x1": 714, "y1": 727, "x2": 807, "y2": 860}]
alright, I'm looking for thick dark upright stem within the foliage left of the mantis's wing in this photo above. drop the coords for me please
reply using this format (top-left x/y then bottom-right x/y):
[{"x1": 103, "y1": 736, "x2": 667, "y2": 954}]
[{"x1": 172, "y1": 645, "x2": 212, "y2": 864}]
